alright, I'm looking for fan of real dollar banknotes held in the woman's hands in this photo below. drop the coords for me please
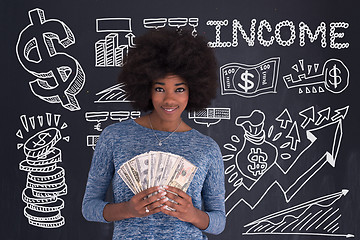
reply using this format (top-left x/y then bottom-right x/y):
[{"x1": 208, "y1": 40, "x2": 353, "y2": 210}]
[{"x1": 117, "y1": 151, "x2": 197, "y2": 194}]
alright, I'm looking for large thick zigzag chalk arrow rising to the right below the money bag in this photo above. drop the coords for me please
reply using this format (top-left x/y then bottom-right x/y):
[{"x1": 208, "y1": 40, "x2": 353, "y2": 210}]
[{"x1": 225, "y1": 119, "x2": 342, "y2": 215}]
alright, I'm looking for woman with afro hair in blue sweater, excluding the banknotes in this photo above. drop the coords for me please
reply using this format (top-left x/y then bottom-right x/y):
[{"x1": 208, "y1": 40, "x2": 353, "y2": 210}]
[{"x1": 82, "y1": 29, "x2": 225, "y2": 239}]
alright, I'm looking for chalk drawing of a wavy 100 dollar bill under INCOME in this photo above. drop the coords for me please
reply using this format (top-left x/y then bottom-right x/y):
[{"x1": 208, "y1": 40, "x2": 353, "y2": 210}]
[{"x1": 220, "y1": 57, "x2": 280, "y2": 98}]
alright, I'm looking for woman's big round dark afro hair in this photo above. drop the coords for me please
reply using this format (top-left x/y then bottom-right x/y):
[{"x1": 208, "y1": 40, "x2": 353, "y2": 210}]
[{"x1": 119, "y1": 28, "x2": 218, "y2": 111}]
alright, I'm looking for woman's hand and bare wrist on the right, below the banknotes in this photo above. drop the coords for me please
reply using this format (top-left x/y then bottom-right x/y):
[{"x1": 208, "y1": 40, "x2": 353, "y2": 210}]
[{"x1": 161, "y1": 186, "x2": 209, "y2": 230}]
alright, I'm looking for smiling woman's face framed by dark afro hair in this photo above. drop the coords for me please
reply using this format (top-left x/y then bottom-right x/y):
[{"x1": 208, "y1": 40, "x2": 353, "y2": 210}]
[{"x1": 151, "y1": 75, "x2": 189, "y2": 122}]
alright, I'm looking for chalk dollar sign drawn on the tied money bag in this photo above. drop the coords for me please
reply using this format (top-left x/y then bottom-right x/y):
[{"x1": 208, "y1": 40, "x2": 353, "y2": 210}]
[{"x1": 247, "y1": 148, "x2": 268, "y2": 177}]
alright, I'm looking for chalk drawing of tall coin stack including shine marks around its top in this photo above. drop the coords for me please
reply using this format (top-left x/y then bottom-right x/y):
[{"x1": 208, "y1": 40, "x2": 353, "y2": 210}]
[{"x1": 16, "y1": 113, "x2": 70, "y2": 228}]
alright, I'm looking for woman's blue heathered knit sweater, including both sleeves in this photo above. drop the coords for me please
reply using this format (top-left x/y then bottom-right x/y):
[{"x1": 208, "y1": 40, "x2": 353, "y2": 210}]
[{"x1": 82, "y1": 120, "x2": 225, "y2": 240}]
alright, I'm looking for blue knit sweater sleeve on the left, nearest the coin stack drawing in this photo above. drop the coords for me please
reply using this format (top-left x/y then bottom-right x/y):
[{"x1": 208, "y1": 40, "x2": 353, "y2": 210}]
[{"x1": 82, "y1": 129, "x2": 114, "y2": 222}]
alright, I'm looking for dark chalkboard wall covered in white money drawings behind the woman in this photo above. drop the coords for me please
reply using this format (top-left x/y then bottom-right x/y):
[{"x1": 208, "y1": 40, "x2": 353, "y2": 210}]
[{"x1": 0, "y1": 0, "x2": 360, "y2": 240}]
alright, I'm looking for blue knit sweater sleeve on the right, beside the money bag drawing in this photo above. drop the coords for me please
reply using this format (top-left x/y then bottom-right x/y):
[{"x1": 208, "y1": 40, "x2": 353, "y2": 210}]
[{"x1": 202, "y1": 141, "x2": 226, "y2": 234}]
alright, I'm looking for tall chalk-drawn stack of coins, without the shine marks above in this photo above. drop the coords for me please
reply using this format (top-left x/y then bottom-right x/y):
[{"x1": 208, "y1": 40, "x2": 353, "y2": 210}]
[{"x1": 19, "y1": 128, "x2": 67, "y2": 228}]
